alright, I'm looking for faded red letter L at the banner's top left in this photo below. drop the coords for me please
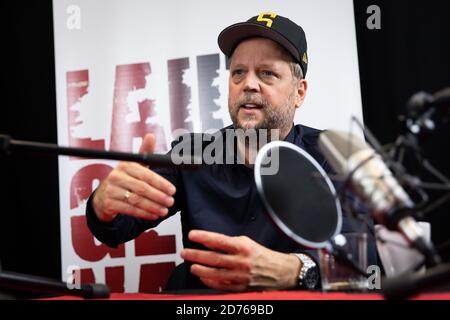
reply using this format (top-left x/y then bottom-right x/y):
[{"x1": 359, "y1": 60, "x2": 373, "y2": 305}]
[{"x1": 66, "y1": 70, "x2": 105, "y2": 151}]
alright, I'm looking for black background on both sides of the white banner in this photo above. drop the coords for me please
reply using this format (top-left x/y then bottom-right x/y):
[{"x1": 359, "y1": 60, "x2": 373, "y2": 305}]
[{"x1": 0, "y1": 0, "x2": 450, "y2": 284}]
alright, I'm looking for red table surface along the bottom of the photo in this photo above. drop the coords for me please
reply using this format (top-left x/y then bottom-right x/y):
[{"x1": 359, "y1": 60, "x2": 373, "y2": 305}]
[{"x1": 41, "y1": 291, "x2": 450, "y2": 300}]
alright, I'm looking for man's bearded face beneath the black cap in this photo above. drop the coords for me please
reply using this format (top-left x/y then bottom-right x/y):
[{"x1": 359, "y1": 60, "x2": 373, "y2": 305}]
[{"x1": 228, "y1": 38, "x2": 306, "y2": 138}]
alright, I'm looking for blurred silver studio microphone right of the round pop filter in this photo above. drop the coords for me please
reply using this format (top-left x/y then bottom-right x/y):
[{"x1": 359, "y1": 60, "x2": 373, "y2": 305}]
[{"x1": 319, "y1": 130, "x2": 440, "y2": 264}]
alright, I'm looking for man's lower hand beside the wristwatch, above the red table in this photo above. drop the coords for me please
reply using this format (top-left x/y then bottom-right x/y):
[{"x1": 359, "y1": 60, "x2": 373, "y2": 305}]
[{"x1": 181, "y1": 230, "x2": 301, "y2": 291}]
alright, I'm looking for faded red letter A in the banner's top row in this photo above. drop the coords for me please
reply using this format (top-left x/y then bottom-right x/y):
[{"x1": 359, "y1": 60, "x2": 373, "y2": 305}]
[{"x1": 111, "y1": 63, "x2": 167, "y2": 152}]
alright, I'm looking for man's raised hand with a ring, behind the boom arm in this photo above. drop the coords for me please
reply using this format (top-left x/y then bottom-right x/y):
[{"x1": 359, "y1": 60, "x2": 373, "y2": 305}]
[{"x1": 92, "y1": 134, "x2": 176, "y2": 222}]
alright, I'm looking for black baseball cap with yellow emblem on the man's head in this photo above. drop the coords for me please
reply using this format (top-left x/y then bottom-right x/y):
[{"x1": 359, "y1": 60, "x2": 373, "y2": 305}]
[{"x1": 217, "y1": 12, "x2": 308, "y2": 76}]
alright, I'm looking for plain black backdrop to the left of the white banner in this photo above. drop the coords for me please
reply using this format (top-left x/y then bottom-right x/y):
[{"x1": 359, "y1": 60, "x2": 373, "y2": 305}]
[{"x1": 0, "y1": 0, "x2": 61, "y2": 278}]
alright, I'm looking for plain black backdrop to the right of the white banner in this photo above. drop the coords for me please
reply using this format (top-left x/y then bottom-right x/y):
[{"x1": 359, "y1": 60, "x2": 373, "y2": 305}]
[{"x1": 354, "y1": 0, "x2": 450, "y2": 260}]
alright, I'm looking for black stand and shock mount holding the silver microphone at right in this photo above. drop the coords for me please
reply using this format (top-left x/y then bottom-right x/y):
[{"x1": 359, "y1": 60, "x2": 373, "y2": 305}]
[{"x1": 324, "y1": 115, "x2": 450, "y2": 299}]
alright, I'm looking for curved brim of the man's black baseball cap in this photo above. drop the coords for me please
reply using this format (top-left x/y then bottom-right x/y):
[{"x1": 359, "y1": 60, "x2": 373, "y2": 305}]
[{"x1": 217, "y1": 22, "x2": 300, "y2": 61}]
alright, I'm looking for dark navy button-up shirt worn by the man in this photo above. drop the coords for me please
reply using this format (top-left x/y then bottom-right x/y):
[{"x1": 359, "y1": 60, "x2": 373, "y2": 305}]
[{"x1": 86, "y1": 125, "x2": 376, "y2": 288}]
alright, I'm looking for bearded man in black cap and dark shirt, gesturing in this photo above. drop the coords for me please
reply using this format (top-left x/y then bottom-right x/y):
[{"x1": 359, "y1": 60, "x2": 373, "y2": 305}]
[{"x1": 87, "y1": 13, "x2": 370, "y2": 291}]
